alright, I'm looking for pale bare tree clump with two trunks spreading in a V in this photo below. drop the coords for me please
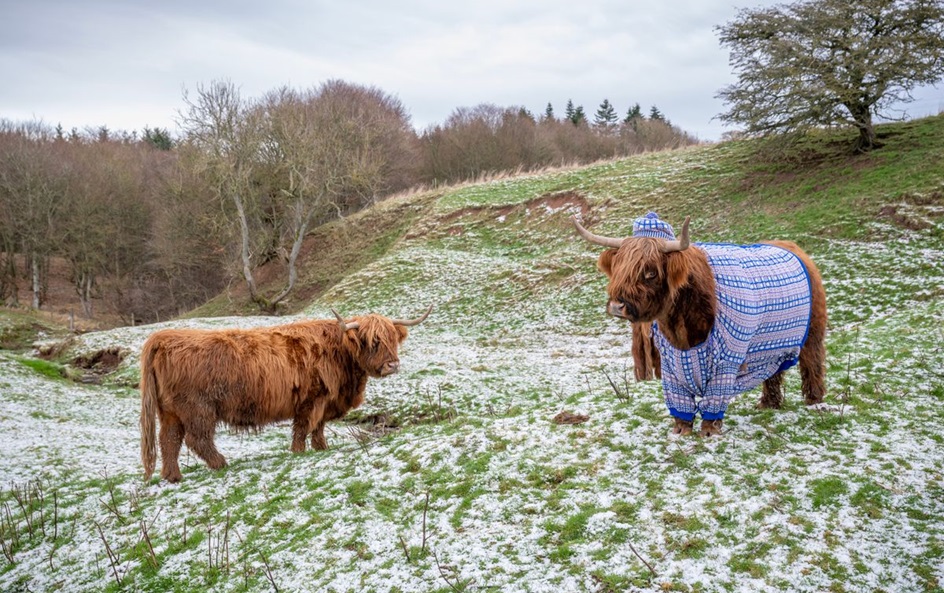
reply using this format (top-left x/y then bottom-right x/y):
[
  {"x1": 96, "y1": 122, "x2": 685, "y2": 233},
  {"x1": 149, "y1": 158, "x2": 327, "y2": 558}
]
[{"x1": 181, "y1": 81, "x2": 415, "y2": 312}]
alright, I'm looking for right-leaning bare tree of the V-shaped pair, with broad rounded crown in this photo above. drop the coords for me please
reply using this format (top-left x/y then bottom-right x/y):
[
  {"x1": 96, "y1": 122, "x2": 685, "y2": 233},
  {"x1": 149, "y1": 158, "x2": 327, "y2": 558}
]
[{"x1": 263, "y1": 80, "x2": 415, "y2": 307}]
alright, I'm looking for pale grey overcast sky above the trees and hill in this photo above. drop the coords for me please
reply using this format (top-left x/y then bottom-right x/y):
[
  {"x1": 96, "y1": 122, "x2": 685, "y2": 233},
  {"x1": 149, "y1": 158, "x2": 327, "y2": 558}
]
[{"x1": 0, "y1": 0, "x2": 944, "y2": 140}]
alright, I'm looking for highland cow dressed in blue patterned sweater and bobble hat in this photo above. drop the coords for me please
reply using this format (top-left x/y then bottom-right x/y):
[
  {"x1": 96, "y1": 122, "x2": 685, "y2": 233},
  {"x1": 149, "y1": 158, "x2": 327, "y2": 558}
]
[{"x1": 573, "y1": 213, "x2": 826, "y2": 436}]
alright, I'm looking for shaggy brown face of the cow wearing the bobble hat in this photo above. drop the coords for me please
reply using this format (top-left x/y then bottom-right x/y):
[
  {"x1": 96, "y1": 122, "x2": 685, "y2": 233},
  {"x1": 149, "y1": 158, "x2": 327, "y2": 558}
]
[{"x1": 597, "y1": 237, "x2": 688, "y2": 322}]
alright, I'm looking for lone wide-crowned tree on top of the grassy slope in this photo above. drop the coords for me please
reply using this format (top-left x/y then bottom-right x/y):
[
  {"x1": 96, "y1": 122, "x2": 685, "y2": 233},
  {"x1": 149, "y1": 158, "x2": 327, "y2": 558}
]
[{"x1": 717, "y1": 0, "x2": 944, "y2": 151}]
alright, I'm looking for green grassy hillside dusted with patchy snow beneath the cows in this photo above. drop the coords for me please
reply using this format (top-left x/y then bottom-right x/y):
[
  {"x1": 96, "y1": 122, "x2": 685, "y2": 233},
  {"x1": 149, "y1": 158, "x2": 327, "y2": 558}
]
[{"x1": 0, "y1": 117, "x2": 944, "y2": 592}]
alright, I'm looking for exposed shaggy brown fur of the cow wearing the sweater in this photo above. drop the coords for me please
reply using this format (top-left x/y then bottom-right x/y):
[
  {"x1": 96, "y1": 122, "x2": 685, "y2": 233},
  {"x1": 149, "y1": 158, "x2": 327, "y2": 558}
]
[{"x1": 597, "y1": 237, "x2": 827, "y2": 436}]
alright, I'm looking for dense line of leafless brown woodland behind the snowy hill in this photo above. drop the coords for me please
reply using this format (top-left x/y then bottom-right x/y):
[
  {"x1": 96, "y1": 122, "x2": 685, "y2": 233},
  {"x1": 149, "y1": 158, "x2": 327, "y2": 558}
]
[{"x1": 0, "y1": 80, "x2": 695, "y2": 321}]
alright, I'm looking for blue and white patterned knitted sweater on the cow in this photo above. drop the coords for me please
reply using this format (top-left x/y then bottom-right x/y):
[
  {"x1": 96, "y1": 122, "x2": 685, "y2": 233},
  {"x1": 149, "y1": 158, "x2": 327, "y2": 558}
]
[{"x1": 653, "y1": 242, "x2": 812, "y2": 421}]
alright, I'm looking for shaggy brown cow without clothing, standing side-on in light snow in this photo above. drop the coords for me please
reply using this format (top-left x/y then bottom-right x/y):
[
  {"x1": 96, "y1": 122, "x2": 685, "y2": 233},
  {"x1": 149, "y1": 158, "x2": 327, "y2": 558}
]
[{"x1": 141, "y1": 306, "x2": 432, "y2": 482}]
